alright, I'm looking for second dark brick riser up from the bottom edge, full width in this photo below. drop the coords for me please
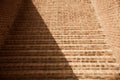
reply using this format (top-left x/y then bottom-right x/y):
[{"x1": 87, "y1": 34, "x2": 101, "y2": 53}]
[{"x1": 0, "y1": 65, "x2": 117, "y2": 71}]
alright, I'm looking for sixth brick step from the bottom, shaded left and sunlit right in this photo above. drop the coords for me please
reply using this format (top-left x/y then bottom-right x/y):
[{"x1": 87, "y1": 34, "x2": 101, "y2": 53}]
[{"x1": 6, "y1": 39, "x2": 106, "y2": 45}]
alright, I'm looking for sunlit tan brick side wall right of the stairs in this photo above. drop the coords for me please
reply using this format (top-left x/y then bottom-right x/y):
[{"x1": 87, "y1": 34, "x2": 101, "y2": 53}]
[{"x1": 91, "y1": 0, "x2": 120, "y2": 60}]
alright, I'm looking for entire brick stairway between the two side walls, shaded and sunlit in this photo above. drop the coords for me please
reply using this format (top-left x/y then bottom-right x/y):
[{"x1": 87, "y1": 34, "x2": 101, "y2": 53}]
[{"x1": 0, "y1": 0, "x2": 119, "y2": 80}]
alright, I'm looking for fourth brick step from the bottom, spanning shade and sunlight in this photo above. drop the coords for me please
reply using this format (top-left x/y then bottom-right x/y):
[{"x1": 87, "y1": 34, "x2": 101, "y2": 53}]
[{"x1": 0, "y1": 50, "x2": 112, "y2": 56}]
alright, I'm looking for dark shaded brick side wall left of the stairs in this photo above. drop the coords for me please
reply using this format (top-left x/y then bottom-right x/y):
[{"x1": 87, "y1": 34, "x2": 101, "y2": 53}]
[{"x1": 0, "y1": 0, "x2": 22, "y2": 46}]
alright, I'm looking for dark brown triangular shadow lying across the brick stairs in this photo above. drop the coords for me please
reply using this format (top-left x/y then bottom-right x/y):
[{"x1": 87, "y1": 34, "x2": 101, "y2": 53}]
[{"x1": 0, "y1": 0, "x2": 78, "y2": 80}]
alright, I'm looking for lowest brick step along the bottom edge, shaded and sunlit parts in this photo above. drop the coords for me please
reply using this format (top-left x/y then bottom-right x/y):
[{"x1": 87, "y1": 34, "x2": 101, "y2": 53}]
[{"x1": 0, "y1": 71, "x2": 114, "y2": 80}]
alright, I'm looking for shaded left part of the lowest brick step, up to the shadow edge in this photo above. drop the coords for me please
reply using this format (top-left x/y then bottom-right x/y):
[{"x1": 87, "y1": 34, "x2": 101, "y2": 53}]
[{"x1": 0, "y1": 69, "x2": 79, "y2": 80}]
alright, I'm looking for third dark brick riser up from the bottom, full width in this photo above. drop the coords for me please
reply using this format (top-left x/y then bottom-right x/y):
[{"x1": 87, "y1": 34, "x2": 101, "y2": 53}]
[{"x1": 0, "y1": 57, "x2": 115, "y2": 65}]
